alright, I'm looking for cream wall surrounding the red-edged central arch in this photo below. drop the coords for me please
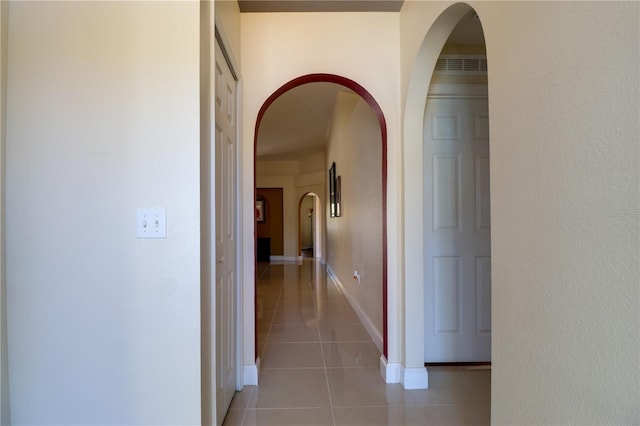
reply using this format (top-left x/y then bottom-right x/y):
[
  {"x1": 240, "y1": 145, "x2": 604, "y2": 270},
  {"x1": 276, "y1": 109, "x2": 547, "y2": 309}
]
[{"x1": 241, "y1": 13, "x2": 402, "y2": 370}]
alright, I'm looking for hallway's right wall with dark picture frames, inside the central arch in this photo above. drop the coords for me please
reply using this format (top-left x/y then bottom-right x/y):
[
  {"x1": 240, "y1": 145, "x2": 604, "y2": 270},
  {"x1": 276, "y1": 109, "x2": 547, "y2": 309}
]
[{"x1": 325, "y1": 91, "x2": 383, "y2": 352}]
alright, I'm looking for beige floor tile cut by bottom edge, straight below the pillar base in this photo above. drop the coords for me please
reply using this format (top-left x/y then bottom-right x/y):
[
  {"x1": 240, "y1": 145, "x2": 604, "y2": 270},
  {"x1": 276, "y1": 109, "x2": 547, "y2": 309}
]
[{"x1": 334, "y1": 406, "x2": 427, "y2": 426}]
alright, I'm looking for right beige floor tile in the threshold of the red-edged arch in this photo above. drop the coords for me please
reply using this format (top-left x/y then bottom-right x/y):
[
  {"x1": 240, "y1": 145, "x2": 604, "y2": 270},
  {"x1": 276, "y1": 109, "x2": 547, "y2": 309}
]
[{"x1": 322, "y1": 342, "x2": 380, "y2": 369}]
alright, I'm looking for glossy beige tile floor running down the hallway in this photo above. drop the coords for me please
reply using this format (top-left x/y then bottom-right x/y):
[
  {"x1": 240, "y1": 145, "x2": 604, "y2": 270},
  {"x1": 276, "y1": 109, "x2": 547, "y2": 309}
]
[{"x1": 224, "y1": 259, "x2": 491, "y2": 426}]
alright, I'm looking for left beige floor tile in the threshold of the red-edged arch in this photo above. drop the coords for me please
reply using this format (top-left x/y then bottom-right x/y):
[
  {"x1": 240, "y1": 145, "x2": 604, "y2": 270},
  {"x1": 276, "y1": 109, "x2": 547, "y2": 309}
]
[{"x1": 261, "y1": 341, "x2": 324, "y2": 369}]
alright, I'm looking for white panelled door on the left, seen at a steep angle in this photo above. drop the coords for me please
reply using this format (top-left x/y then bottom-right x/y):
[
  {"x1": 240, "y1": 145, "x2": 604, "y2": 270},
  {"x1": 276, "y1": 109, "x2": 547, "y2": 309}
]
[{"x1": 211, "y1": 42, "x2": 237, "y2": 425}]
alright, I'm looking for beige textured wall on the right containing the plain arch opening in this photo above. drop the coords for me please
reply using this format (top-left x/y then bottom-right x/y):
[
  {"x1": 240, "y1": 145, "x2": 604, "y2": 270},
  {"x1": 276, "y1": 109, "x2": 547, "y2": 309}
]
[{"x1": 401, "y1": 2, "x2": 640, "y2": 425}]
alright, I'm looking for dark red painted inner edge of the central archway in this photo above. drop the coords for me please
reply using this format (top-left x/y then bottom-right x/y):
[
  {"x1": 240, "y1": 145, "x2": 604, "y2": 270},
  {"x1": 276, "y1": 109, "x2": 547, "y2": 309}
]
[{"x1": 254, "y1": 74, "x2": 387, "y2": 357}]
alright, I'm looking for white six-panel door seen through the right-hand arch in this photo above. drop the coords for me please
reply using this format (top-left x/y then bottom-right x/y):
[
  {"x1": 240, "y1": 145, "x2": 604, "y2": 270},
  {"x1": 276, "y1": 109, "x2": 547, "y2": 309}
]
[{"x1": 424, "y1": 93, "x2": 491, "y2": 362}]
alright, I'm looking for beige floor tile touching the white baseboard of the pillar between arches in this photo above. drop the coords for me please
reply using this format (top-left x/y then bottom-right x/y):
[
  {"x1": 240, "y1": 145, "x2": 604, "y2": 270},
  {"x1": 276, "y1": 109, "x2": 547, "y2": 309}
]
[{"x1": 327, "y1": 368, "x2": 407, "y2": 407}]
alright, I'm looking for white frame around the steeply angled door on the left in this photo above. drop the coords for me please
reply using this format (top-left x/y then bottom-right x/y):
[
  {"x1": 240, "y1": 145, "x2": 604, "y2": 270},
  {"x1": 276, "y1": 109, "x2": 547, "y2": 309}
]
[{"x1": 200, "y1": 22, "x2": 244, "y2": 424}]
